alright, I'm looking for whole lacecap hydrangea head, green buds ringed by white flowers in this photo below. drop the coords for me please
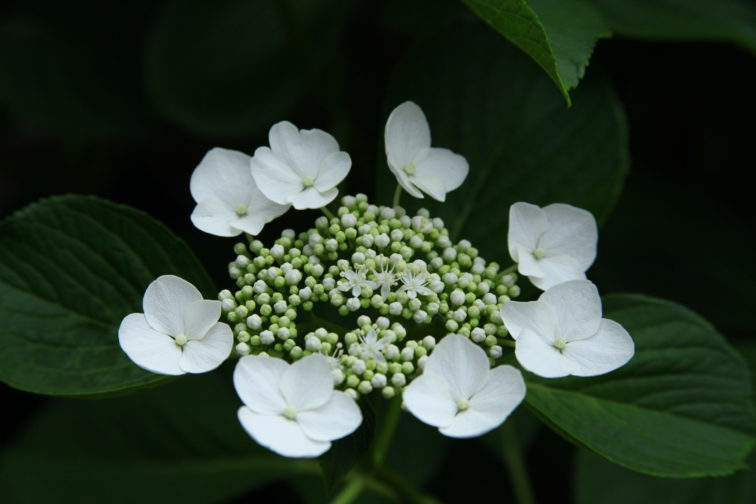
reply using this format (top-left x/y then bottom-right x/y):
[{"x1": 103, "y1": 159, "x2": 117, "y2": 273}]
[{"x1": 119, "y1": 102, "x2": 634, "y2": 457}]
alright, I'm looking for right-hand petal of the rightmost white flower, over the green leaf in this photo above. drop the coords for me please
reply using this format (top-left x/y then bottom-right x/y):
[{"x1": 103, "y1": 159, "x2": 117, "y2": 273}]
[{"x1": 564, "y1": 319, "x2": 635, "y2": 376}]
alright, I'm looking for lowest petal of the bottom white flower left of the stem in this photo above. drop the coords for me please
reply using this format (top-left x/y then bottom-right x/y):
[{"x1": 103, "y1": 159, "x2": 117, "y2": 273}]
[{"x1": 238, "y1": 406, "x2": 331, "y2": 457}]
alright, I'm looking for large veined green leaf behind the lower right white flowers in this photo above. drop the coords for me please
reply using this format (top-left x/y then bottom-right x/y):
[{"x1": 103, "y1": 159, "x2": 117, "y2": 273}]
[{"x1": 526, "y1": 295, "x2": 756, "y2": 477}]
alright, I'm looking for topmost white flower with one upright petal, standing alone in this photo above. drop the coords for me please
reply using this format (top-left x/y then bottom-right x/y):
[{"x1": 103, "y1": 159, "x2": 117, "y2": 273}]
[{"x1": 385, "y1": 101, "x2": 470, "y2": 201}]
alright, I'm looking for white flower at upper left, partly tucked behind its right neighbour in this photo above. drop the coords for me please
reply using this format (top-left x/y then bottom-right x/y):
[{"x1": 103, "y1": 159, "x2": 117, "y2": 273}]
[{"x1": 189, "y1": 147, "x2": 290, "y2": 236}]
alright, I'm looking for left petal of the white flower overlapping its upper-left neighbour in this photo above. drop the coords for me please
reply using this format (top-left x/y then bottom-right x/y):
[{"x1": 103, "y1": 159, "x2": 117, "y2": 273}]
[{"x1": 250, "y1": 147, "x2": 304, "y2": 205}]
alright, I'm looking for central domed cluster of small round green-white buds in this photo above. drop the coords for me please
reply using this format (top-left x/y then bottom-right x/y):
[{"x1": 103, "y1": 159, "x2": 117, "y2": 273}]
[{"x1": 219, "y1": 194, "x2": 519, "y2": 398}]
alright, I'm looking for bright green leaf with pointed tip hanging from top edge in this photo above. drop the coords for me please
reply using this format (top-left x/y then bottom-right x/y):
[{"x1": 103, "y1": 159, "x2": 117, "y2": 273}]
[{"x1": 464, "y1": 0, "x2": 611, "y2": 104}]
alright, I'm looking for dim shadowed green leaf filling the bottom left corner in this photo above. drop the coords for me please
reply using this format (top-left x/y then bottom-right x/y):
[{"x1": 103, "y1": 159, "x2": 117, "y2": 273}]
[{"x1": 0, "y1": 372, "x2": 318, "y2": 504}]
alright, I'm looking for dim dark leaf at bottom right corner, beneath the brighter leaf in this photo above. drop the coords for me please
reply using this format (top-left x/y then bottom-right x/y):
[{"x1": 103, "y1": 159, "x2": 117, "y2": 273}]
[{"x1": 575, "y1": 450, "x2": 756, "y2": 504}]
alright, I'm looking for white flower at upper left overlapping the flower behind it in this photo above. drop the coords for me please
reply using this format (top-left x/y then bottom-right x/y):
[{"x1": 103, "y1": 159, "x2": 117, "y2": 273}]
[{"x1": 251, "y1": 121, "x2": 352, "y2": 210}]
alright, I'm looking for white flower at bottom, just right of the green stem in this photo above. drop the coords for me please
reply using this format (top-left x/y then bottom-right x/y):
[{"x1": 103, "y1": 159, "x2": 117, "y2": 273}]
[{"x1": 403, "y1": 334, "x2": 525, "y2": 438}]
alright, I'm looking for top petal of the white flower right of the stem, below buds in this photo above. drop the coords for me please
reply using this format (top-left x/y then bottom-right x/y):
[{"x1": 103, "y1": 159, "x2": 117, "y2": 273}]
[{"x1": 425, "y1": 334, "x2": 490, "y2": 400}]
